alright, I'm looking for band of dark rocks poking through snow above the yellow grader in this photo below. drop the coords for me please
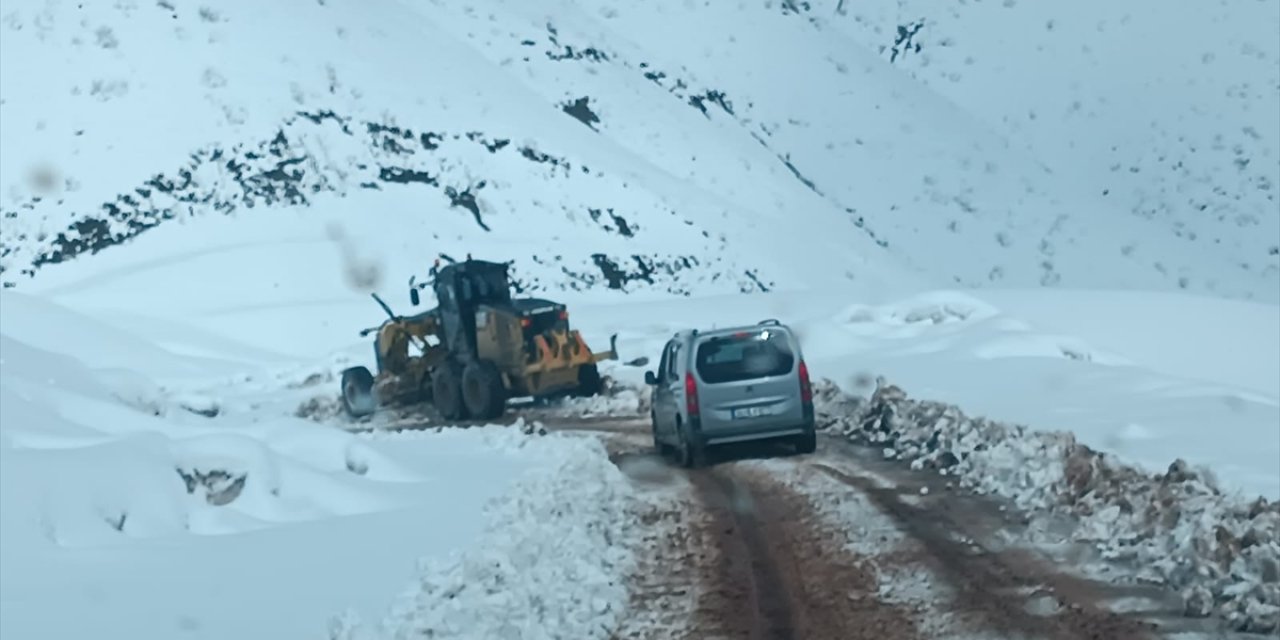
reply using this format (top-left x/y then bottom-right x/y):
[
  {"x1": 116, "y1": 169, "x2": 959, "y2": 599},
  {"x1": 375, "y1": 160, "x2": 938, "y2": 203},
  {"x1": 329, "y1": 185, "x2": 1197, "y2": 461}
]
[{"x1": 0, "y1": 108, "x2": 773, "y2": 296}]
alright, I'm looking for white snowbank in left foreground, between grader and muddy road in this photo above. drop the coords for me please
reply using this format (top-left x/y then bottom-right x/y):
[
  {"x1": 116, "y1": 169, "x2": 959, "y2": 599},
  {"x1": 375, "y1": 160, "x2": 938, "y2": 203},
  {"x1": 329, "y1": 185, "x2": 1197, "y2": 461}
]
[{"x1": 0, "y1": 292, "x2": 628, "y2": 640}]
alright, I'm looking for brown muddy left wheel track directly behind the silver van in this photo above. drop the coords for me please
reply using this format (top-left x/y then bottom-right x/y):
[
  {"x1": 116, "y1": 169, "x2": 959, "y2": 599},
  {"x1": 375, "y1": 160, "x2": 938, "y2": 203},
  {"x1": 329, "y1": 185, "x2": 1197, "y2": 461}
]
[{"x1": 689, "y1": 465, "x2": 920, "y2": 640}]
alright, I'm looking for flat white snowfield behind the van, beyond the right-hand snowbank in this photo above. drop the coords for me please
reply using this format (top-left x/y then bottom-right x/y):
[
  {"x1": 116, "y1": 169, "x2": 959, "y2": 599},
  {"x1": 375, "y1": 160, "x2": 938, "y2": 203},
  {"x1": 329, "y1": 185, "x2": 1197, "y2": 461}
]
[{"x1": 575, "y1": 289, "x2": 1280, "y2": 500}]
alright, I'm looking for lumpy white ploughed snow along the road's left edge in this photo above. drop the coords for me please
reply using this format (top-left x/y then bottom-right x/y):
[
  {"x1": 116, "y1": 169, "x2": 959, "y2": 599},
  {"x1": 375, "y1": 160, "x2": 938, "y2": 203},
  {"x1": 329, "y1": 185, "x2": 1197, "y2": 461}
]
[{"x1": 330, "y1": 430, "x2": 637, "y2": 640}]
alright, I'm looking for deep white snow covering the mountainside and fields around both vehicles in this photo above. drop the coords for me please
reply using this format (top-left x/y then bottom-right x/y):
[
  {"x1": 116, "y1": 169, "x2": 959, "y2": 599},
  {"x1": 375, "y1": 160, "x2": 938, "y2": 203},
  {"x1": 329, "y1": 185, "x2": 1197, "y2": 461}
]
[{"x1": 0, "y1": 0, "x2": 1280, "y2": 637}]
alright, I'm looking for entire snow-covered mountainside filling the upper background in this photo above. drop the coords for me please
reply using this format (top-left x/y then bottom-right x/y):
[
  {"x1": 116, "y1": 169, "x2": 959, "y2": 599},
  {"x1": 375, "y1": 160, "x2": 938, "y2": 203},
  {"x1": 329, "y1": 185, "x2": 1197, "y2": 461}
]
[{"x1": 0, "y1": 0, "x2": 1280, "y2": 304}]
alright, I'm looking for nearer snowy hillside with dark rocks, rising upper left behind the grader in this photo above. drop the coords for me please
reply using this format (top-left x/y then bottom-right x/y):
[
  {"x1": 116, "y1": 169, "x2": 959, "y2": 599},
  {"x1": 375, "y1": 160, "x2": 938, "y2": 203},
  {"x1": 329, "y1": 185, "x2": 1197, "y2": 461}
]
[{"x1": 0, "y1": 1, "x2": 916, "y2": 298}]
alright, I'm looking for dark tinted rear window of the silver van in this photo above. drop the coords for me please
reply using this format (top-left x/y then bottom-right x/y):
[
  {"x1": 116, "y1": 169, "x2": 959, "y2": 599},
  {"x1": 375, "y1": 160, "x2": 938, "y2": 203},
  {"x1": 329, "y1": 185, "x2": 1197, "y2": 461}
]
[{"x1": 695, "y1": 329, "x2": 795, "y2": 384}]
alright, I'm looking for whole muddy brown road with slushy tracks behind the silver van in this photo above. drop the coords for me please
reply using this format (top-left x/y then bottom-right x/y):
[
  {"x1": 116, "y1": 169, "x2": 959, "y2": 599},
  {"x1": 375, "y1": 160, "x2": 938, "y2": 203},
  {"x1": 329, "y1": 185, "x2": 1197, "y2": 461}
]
[{"x1": 353, "y1": 408, "x2": 1218, "y2": 640}]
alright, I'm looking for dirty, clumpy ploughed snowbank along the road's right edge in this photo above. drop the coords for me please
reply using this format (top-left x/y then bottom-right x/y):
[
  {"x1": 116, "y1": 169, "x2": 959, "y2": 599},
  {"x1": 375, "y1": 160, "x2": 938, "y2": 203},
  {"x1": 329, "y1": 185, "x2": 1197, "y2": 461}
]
[{"x1": 815, "y1": 380, "x2": 1280, "y2": 632}]
